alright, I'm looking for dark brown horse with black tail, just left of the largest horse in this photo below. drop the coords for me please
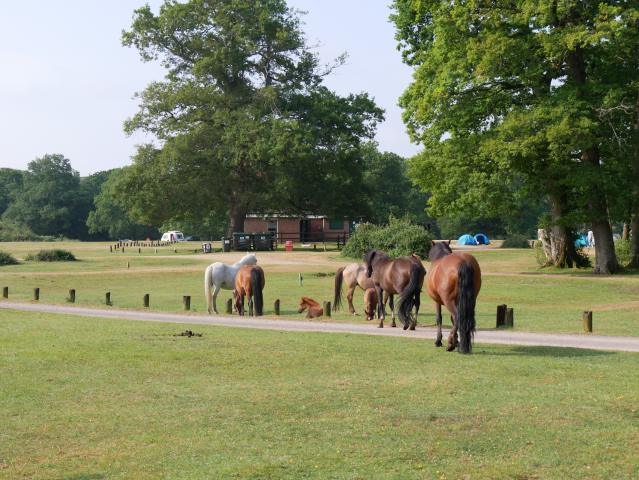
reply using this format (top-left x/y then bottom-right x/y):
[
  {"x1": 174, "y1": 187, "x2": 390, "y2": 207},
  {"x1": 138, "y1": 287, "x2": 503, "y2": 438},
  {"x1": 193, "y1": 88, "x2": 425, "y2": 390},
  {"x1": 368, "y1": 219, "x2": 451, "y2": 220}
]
[{"x1": 364, "y1": 250, "x2": 426, "y2": 330}]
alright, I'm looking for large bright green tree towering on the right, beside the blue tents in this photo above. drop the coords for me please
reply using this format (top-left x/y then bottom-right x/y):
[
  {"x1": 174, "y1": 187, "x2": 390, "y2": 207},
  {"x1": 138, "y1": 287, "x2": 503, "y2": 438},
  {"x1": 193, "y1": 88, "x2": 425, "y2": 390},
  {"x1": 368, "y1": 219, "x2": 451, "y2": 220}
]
[{"x1": 392, "y1": 0, "x2": 636, "y2": 273}]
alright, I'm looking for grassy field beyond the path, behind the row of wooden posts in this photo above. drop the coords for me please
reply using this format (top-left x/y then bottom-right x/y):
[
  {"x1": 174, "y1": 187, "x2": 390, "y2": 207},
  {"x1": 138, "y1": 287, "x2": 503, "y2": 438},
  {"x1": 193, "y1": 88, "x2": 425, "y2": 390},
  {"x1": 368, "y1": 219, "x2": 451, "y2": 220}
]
[{"x1": 0, "y1": 242, "x2": 639, "y2": 335}]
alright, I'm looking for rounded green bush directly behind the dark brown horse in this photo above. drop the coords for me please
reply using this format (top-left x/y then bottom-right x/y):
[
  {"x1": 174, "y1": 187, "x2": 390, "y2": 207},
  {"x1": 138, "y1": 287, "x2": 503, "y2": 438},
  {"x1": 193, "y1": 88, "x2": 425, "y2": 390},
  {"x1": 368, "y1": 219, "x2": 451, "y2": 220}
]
[{"x1": 342, "y1": 217, "x2": 434, "y2": 259}]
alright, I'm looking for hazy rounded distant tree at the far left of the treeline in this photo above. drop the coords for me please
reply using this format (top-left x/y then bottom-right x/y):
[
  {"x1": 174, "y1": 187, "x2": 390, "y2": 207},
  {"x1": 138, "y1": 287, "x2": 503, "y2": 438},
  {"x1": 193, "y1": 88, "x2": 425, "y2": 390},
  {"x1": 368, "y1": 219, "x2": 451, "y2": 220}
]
[{"x1": 3, "y1": 154, "x2": 80, "y2": 235}]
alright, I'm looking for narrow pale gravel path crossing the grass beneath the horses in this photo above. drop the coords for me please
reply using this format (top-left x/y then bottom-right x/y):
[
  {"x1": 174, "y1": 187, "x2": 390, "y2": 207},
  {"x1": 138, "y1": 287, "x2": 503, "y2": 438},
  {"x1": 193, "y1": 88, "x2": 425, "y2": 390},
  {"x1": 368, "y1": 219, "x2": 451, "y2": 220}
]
[{"x1": 0, "y1": 301, "x2": 639, "y2": 352}]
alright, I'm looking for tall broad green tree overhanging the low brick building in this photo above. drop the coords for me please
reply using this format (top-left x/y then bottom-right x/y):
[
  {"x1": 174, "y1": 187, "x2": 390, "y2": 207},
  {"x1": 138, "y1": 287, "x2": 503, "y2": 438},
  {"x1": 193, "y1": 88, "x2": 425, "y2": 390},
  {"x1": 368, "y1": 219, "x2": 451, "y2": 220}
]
[{"x1": 117, "y1": 0, "x2": 382, "y2": 233}]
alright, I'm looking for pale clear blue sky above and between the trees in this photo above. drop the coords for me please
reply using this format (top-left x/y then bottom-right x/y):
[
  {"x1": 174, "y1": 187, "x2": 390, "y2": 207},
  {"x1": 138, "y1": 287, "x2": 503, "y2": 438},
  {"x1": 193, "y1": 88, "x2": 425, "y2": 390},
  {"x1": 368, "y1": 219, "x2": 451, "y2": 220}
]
[{"x1": 0, "y1": 0, "x2": 417, "y2": 175}]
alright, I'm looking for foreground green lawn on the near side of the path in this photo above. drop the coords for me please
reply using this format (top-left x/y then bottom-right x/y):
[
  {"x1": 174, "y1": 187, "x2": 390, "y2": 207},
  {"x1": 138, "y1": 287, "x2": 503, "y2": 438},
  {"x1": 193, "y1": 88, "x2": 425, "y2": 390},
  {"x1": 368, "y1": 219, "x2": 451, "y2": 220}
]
[{"x1": 0, "y1": 311, "x2": 639, "y2": 479}]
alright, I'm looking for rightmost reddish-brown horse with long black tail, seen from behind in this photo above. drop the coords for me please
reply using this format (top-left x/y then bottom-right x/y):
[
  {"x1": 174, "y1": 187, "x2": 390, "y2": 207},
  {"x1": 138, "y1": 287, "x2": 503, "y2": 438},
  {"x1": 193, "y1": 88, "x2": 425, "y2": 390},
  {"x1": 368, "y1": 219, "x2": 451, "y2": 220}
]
[{"x1": 426, "y1": 240, "x2": 481, "y2": 353}]
